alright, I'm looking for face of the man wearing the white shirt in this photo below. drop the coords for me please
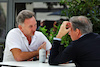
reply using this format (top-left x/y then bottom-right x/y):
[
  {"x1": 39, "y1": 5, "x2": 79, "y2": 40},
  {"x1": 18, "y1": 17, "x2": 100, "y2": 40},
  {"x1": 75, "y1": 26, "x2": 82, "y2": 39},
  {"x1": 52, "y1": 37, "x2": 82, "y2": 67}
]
[{"x1": 22, "y1": 17, "x2": 37, "y2": 36}]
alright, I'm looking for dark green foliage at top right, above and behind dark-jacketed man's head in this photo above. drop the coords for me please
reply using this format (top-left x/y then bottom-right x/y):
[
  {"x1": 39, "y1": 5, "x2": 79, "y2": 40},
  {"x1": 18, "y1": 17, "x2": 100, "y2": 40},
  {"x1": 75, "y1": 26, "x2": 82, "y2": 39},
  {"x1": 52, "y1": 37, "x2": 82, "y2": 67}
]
[{"x1": 61, "y1": 0, "x2": 100, "y2": 34}]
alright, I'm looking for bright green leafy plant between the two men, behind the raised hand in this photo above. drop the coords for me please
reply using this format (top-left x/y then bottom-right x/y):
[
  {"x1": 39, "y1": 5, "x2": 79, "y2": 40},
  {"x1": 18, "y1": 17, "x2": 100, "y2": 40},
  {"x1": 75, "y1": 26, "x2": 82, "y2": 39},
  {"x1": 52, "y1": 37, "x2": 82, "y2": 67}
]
[{"x1": 40, "y1": 24, "x2": 71, "y2": 47}]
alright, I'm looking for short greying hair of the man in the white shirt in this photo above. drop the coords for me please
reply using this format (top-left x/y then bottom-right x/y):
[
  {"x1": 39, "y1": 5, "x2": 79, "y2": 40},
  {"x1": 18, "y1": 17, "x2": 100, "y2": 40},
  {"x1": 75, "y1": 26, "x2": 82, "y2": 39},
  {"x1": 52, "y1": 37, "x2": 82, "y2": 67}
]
[{"x1": 16, "y1": 10, "x2": 34, "y2": 25}]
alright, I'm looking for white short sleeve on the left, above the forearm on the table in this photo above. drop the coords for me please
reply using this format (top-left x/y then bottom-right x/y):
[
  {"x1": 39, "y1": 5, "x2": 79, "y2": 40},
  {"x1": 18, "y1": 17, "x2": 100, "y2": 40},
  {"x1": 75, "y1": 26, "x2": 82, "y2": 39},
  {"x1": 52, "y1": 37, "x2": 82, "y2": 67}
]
[{"x1": 5, "y1": 31, "x2": 21, "y2": 50}]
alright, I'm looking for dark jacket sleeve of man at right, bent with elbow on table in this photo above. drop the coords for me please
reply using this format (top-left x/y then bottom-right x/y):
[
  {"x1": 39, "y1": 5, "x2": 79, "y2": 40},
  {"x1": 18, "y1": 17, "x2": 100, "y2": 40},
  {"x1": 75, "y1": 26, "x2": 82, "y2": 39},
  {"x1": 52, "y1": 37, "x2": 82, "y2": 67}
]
[{"x1": 49, "y1": 40, "x2": 74, "y2": 65}]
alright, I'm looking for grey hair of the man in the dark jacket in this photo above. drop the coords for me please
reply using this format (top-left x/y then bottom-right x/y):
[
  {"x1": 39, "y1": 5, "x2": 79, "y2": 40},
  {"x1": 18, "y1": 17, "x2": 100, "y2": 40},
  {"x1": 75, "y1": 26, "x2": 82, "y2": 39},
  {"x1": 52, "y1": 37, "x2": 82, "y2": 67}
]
[{"x1": 69, "y1": 16, "x2": 93, "y2": 34}]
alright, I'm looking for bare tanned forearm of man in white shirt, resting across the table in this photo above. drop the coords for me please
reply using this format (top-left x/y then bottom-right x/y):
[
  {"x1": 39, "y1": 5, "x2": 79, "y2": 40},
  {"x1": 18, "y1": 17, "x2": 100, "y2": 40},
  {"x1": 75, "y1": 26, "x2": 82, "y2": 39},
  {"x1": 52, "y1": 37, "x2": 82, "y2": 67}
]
[{"x1": 11, "y1": 48, "x2": 39, "y2": 61}]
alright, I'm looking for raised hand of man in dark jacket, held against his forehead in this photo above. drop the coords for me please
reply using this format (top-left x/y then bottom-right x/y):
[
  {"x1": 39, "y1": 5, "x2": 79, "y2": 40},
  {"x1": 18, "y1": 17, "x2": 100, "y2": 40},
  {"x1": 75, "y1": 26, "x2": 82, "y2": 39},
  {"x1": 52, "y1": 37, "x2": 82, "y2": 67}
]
[{"x1": 56, "y1": 21, "x2": 71, "y2": 39}]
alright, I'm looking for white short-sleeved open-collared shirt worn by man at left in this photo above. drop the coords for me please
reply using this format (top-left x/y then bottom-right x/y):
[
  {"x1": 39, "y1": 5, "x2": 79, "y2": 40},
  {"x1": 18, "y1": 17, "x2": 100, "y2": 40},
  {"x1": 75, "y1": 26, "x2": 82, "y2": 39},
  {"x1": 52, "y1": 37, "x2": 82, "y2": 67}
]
[{"x1": 3, "y1": 28, "x2": 51, "y2": 61}]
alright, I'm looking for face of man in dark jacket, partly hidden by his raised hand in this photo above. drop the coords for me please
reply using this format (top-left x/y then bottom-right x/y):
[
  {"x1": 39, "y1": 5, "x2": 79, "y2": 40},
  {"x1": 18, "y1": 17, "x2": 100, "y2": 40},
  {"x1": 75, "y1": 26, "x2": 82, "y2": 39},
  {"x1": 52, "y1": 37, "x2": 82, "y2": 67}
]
[{"x1": 69, "y1": 24, "x2": 80, "y2": 41}]
